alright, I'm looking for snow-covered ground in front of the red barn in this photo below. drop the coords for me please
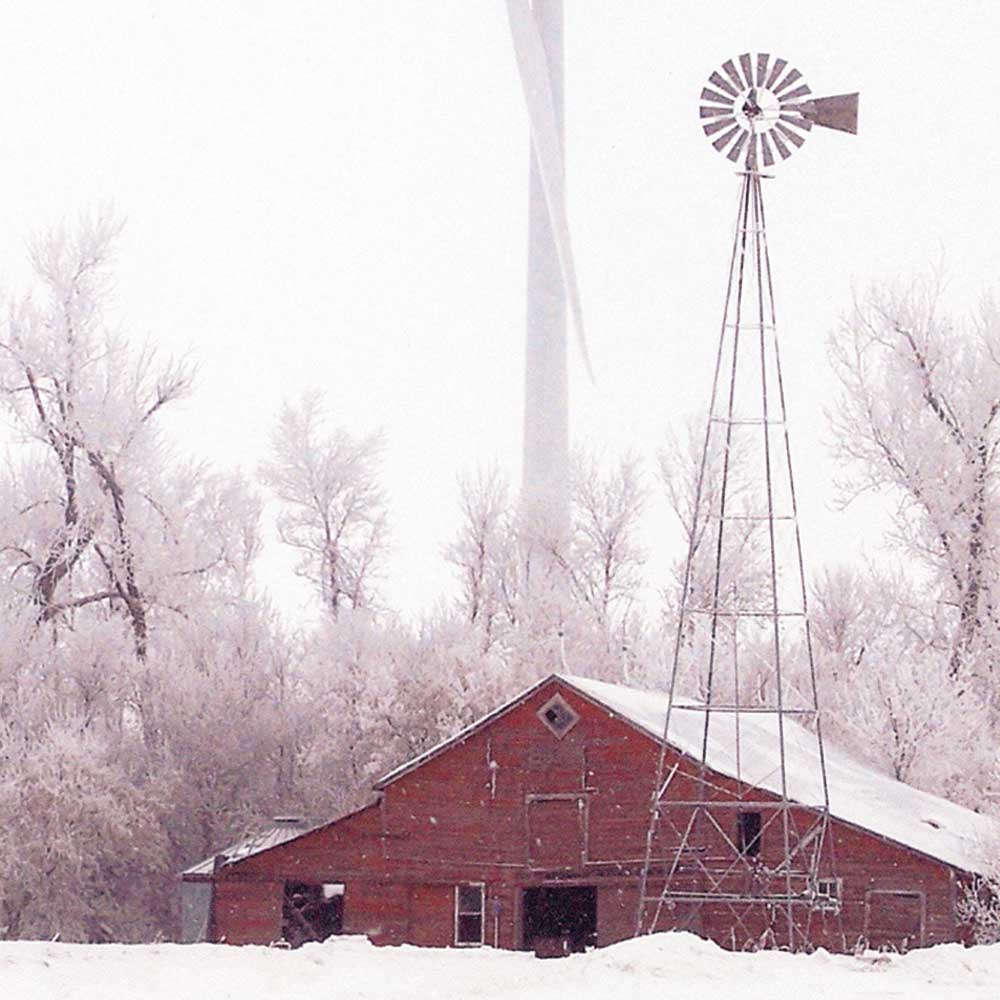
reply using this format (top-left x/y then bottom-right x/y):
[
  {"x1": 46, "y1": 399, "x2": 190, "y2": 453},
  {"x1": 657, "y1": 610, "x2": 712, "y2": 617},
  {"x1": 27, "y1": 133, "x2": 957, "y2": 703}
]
[{"x1": 0, "y1": 934, "x2": 1000, "y2": 1000}]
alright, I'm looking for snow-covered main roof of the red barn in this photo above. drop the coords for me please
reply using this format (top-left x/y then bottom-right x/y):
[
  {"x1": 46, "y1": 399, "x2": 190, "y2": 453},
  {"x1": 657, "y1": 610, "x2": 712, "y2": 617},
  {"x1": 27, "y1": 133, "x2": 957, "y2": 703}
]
[{"x1": 375, "y1": 674, "x2": 1000, "y2": 873}]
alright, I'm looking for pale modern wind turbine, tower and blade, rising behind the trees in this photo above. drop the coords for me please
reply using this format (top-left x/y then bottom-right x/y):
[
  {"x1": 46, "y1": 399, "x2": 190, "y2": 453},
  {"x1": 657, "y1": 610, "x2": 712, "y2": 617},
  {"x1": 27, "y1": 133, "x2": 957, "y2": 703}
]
[{"x1": 507, "y1": 0, "x2": 591, "y2": 569}]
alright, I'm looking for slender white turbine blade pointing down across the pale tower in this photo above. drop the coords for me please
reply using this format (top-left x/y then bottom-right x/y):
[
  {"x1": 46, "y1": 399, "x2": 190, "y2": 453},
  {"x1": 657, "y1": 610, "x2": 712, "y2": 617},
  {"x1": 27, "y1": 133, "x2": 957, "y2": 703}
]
[{"x1": 507, "y1": 0, "x2": 594, "y2": 382}]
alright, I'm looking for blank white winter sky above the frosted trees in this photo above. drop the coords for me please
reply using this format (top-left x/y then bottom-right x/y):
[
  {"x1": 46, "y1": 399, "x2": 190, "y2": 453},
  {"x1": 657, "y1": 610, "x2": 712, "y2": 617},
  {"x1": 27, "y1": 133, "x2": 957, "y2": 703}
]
[{"x1": 0, "y1": 0, "x2": 1000, "y2": 615}]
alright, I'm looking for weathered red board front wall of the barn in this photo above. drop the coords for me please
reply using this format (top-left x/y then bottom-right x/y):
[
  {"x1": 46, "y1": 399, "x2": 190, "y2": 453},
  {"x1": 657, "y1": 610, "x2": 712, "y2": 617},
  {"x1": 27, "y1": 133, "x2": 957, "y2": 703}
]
[{"x1": 205, "y1": 681, "x2": 976, "y2": 949}]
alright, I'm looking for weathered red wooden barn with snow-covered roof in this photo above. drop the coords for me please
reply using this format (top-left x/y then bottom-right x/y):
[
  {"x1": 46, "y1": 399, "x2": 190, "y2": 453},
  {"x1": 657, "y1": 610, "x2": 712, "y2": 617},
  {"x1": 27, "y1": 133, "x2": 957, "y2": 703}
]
[{"x1": 183, "y1": 675, "x2": 998, "y2": 950}]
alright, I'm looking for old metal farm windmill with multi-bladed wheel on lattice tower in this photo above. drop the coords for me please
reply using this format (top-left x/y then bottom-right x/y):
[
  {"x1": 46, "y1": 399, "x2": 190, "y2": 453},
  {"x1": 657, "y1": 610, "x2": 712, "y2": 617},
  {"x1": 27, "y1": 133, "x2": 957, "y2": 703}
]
[{"x1": 637, "y1": 53, "x2": 858, "y2": 949}]
